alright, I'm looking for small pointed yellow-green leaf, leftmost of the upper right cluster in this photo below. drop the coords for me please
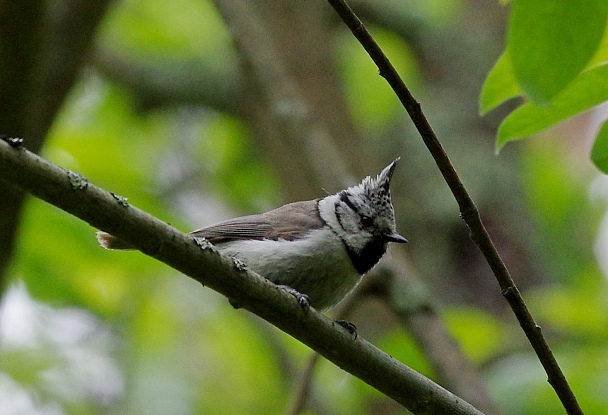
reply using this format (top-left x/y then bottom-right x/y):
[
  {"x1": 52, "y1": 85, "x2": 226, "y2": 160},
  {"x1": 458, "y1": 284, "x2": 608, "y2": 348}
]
[{"x1": 479, "y1": 49, "x2": 522, "y2": 115}]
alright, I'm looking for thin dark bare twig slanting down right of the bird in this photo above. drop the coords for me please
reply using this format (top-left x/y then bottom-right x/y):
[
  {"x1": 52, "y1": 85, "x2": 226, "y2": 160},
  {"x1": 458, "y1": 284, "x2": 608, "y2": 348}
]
[{"x1": 328, "y1": 0, "x2": 583, "y2": 414}]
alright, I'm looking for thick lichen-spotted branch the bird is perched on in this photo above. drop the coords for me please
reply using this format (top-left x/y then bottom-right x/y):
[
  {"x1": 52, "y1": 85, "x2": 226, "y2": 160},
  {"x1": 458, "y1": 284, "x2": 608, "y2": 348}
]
[{"x1": 0, "y1": 140, "x2": 481, "y2": 415}]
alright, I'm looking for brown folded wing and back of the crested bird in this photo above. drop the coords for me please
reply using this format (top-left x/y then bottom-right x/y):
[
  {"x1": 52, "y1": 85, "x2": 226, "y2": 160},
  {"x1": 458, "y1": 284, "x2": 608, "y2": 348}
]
[{"x1": 190, "y1": 200, "x2": 324, "y2": 244}]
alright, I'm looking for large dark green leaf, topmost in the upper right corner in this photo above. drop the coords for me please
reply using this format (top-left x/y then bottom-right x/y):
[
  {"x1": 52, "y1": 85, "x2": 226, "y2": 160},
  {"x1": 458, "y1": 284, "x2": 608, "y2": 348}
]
[{"x1": 507, "y1": 0, "x2": 608, "y2": 104}]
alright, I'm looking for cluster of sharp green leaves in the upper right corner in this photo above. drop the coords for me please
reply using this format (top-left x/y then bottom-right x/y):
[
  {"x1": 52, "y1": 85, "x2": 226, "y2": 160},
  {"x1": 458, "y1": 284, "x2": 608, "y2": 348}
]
[{"x1": 480, "y1": 0, "x2": 608, "y2": 173}]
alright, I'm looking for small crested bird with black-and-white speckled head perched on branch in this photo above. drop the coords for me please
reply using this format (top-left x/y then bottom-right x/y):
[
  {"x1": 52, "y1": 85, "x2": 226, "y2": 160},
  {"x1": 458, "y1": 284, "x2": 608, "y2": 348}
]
[{"x1": 97, "y1": 159, "x2": 407, "y2": 311}]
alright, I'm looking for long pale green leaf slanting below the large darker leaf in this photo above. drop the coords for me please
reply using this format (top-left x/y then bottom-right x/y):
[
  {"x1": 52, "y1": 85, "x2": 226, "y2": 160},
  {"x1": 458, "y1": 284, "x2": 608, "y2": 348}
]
[{"x1": 496, "y1": 65, "x2": 608, "y2": 150}]
